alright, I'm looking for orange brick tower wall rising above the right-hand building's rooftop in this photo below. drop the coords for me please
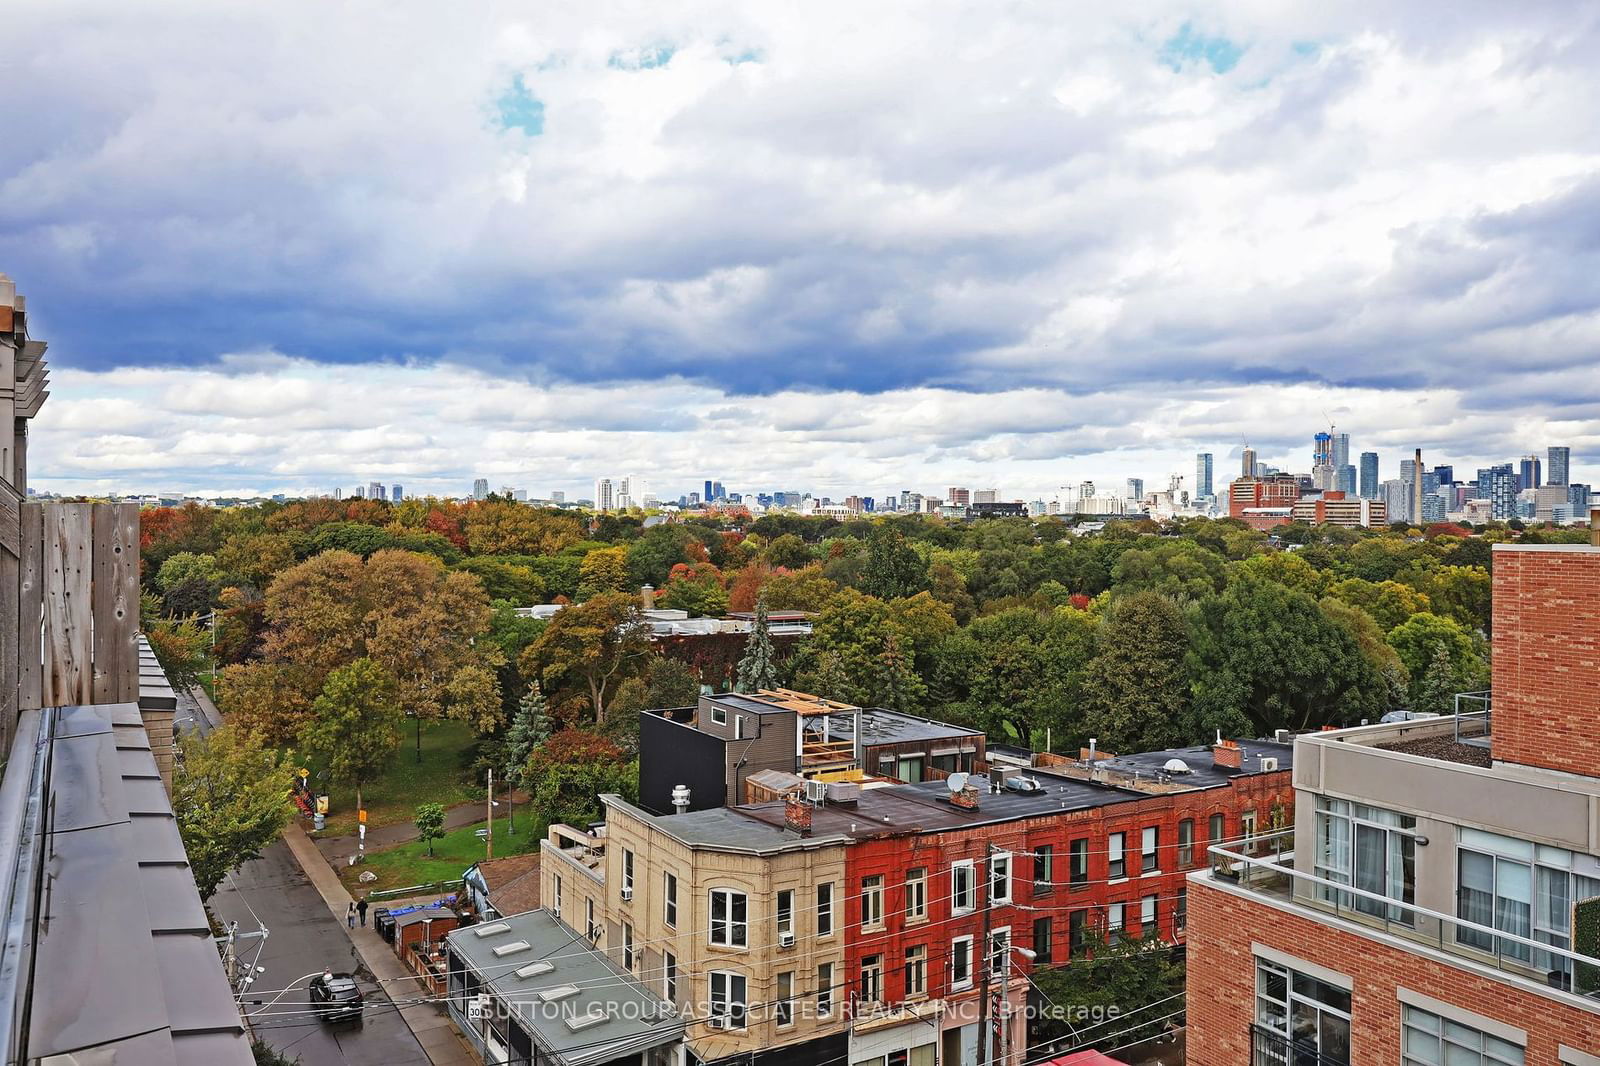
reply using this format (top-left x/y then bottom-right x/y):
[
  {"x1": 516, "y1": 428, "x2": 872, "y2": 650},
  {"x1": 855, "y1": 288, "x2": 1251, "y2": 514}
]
[{"x1": 1493, "y1": 546, "x2": 1600, "y2": 776}]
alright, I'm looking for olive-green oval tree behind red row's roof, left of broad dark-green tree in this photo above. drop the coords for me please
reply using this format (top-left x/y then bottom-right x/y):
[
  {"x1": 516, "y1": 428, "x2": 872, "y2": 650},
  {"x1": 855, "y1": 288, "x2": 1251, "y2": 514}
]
[{"x1": 1083, "y1": 589, "x2": 1197, "y2": 751}]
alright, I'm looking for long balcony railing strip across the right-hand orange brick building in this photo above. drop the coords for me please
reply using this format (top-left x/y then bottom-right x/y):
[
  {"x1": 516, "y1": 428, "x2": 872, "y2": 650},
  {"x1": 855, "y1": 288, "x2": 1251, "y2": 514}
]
[{"x1": 1210, "y1": 829, "x2": 1600, "y2": 1011}]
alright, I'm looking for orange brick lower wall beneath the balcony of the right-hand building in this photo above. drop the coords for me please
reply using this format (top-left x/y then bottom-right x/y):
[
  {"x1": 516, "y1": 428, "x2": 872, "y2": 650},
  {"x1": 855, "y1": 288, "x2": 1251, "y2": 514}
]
[{"x1": 1187, "y1": 877, "x2": 1600, "y2": 1066}]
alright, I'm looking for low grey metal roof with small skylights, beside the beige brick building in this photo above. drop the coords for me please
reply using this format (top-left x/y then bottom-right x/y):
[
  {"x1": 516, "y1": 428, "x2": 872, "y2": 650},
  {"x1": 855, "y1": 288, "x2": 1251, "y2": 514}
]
[{"x1": 445, "y1": 909, "x2": 683, "y2": 1066}]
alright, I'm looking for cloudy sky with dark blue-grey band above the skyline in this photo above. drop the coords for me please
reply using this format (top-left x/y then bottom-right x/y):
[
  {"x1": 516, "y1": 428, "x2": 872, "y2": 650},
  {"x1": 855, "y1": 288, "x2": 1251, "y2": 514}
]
[{"x1": 0, "y1": 0, "x2": 1600, "y2": 498}]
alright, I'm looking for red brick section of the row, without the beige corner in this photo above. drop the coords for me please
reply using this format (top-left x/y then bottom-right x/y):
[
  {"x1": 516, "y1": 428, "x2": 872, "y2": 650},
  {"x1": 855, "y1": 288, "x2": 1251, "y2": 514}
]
[{"x1": 741, "y1": 741, "x2": 1293, "y2": 1066}]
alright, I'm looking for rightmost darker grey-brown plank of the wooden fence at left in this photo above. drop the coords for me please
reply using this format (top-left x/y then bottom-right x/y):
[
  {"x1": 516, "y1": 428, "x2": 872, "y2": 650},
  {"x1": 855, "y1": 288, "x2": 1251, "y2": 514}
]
[{"x1": 93, "y1": 504, "x2": 139, "y2": 703}]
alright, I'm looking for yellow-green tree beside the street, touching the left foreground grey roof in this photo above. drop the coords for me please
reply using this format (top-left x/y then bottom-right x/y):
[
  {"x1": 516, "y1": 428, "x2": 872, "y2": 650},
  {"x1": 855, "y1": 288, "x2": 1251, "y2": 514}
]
[{"x1": 173, "y1": 725, "x2": 294, "y2": 900}]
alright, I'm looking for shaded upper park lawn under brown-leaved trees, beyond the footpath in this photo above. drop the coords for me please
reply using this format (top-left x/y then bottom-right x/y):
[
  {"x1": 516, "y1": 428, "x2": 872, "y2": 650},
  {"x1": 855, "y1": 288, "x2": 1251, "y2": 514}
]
[{"x1": 325, "y1": 720, "x2": 483, "y2": 832}]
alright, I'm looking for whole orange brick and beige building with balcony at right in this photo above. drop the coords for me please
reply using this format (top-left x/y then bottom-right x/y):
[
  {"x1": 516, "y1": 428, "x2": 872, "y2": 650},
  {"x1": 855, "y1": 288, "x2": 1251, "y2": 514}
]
[{"x1": 1187, "y1": 534, "x2": 1600, "y2": 1066}]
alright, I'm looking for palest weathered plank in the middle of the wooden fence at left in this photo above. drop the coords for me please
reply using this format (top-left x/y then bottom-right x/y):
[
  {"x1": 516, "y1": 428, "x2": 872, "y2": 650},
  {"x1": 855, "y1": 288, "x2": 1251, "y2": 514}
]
[{"x1": 42, "y1": 504, "x2": 94, "y2": 707}]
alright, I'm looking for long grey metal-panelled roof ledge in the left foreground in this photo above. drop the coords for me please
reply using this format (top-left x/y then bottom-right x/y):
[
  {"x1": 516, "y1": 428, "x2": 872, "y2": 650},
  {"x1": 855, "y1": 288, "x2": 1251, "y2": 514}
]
[{"x1": 0, "y1": 703, "x2": 253, "y2": 1066}]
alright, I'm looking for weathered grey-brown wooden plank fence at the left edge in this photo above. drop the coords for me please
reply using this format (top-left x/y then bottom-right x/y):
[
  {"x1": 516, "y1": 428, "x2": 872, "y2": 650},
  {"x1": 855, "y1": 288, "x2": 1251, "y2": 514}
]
[{"x1": 0, "y1": 491, "x2": 139, "y2": 722}]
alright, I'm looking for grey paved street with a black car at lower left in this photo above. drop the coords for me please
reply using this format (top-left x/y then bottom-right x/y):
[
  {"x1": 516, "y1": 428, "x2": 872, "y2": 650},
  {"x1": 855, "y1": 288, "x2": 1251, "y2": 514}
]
[{"x1": 211, "y1": 840, "x2": 429, "y2": 1066}]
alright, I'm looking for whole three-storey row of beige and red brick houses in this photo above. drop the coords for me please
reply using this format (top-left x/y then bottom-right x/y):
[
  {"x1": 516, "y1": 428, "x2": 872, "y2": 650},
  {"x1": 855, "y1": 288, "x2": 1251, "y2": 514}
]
[{"x1": 541, "y1": 694, "x2": 1293, "y2": 1066}]
